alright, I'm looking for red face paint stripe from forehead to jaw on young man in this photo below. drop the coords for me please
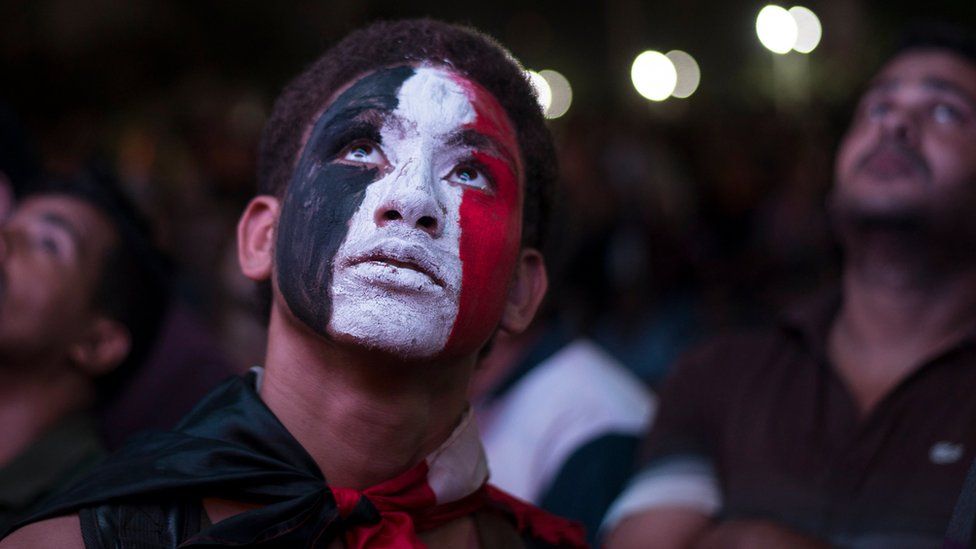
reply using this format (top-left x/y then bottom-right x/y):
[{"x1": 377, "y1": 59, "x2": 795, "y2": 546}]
[{"x1": 445, "y1": 76, "x2": 522, "y2": 353}]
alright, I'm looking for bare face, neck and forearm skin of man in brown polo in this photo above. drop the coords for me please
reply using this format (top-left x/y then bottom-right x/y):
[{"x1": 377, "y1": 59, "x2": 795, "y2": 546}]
[{"x1": 608, "y1": 49, "x2": 976, "y2": 549}]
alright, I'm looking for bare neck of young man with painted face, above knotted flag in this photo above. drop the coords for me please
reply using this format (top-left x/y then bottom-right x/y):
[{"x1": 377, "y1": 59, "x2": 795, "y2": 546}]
[{"x1": 261, "y1": 307, "x2": 474, "y2": 489}]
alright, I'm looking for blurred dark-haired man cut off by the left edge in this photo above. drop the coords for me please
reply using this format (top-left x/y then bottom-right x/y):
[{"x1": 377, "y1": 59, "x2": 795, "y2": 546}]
[{"x1": 0, "y1": 170, "x2": 165, "y2": 530}]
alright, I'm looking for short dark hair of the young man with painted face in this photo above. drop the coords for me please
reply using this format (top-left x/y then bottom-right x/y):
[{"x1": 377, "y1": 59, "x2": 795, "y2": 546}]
[{"x1": 258, "y1": 19, "x2": 556, "y2": 247}]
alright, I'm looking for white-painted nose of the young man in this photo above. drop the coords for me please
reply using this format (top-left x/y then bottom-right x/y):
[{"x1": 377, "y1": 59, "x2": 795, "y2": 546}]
[{"x1": 375, "y1": 162, "x2": 445, "y2": 237}]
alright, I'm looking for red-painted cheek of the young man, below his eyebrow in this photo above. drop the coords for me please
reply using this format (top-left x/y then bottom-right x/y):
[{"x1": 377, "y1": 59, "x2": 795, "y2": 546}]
[{"x1": 447, "y1": 155, "x2": 522, "y2": 351}]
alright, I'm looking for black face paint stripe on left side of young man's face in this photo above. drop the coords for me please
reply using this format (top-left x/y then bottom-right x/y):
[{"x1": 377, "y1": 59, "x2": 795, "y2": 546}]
[{"x1": 275, "y1": 67, "x2": 414, "y2": 335}]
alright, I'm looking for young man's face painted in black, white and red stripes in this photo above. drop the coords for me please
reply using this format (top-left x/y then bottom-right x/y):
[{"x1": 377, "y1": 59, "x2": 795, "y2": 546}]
[{"x1": 275, "y1": 66, "x2": 523, "y2": 358}]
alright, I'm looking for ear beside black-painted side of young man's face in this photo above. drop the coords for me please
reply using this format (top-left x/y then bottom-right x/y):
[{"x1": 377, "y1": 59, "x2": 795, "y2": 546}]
[{"x1": 237, "y1": 195, "x2": 278, "y2": 281}]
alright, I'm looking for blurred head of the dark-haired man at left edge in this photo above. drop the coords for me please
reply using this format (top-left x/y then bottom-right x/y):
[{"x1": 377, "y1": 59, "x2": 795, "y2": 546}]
[{"x1": 0, "y1": 170, "x2": 167, "y2": 399}]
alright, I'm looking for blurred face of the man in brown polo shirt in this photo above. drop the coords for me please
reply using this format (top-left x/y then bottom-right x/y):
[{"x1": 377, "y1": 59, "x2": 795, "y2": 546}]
[{"x1": 832, "y1": 49, "x2": 976, "y2": 231}]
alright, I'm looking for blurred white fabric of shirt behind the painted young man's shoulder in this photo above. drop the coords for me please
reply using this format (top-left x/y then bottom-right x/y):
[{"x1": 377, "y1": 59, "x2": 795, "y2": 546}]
[{"x1": 477, "y1": 340, "x2": 656, "y2": 504}]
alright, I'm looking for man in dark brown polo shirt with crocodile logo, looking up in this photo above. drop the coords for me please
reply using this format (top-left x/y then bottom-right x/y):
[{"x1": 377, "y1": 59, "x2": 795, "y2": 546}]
[{"x1": 605, "y1": 23, "x2": 976, "y2": 548}]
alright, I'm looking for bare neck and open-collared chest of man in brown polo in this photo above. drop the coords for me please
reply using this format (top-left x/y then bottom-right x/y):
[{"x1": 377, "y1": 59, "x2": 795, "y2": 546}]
[{"x1": 829, "y1": 228, "x2": 976, "y2": 411}]
